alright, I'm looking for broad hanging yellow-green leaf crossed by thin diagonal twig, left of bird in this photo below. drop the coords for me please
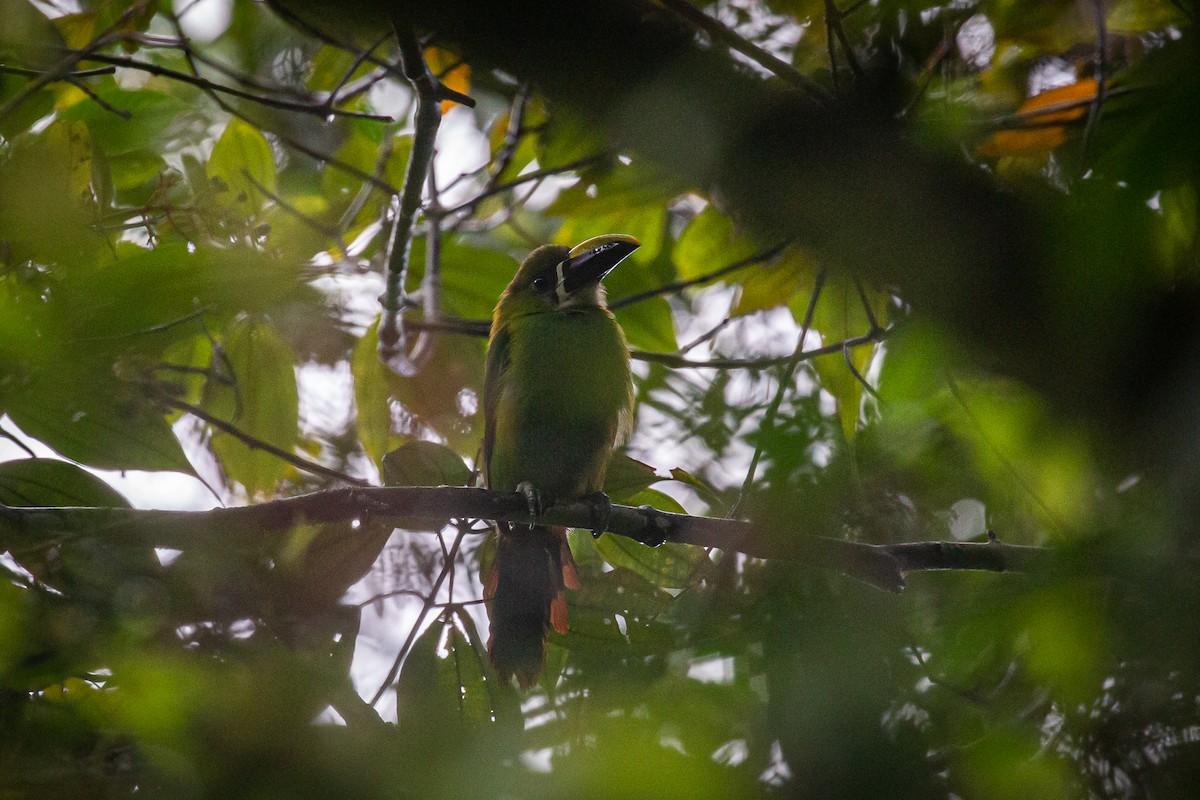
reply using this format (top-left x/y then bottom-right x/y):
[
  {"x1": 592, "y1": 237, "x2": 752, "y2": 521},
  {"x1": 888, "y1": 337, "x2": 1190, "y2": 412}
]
[{"x1": 203, "y1": 321, "x2": 300, "y2": 494}]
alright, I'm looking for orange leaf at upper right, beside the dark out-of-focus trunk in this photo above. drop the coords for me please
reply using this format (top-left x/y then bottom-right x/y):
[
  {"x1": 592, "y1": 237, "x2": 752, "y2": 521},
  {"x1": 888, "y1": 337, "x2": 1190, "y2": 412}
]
[{"x1": 977, "y1": 78, "x2": 1097, "y2": 156}]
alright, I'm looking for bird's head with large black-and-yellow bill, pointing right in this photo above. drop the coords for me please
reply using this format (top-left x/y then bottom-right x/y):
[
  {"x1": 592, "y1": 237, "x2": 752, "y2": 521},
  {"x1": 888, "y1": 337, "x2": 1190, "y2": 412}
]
[{"x1": 498, "y1": 234, "x2": 641, "y2": 315}]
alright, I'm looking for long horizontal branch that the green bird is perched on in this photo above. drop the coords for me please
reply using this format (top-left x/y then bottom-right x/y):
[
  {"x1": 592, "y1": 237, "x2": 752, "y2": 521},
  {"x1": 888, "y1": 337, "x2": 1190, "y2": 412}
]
[{"x1": 0, "y1": 486, "x2": 1050, "y2": 591}]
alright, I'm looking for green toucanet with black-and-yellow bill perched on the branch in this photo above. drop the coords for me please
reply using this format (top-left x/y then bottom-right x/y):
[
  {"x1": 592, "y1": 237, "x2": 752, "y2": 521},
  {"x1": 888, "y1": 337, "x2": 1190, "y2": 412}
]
[{"x1": 481, "y1": 234, "x2": 640, "y2": 688}]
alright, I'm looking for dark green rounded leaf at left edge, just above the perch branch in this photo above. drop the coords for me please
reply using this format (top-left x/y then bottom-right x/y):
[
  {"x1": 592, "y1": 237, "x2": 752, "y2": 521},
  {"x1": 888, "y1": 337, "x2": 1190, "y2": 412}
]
[{"x1": 0, "y1": 458, "x2": 130, "y2": 509}]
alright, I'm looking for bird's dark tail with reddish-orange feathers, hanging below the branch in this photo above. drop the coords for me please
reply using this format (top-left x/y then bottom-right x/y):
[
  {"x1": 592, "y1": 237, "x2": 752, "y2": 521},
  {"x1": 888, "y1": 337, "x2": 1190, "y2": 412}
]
[{"x1": 484, "y1": 524, "x2": 580, "y2": 688}]
